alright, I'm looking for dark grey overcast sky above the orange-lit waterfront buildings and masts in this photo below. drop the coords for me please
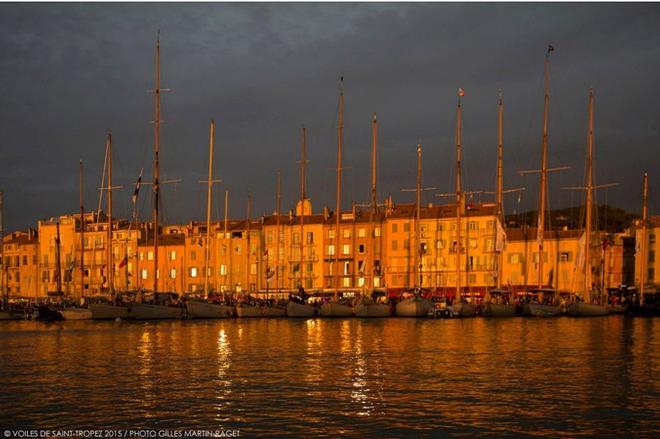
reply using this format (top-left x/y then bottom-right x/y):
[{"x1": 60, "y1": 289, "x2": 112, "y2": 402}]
[{"x1": 0, "y1": 3, "x2": 660, "y2": 231}]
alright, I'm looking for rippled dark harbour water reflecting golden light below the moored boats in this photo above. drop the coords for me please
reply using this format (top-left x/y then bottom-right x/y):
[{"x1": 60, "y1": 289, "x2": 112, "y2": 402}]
[{"x1": 0, "y1": 316, "x2": 660, "y2": 437}]
